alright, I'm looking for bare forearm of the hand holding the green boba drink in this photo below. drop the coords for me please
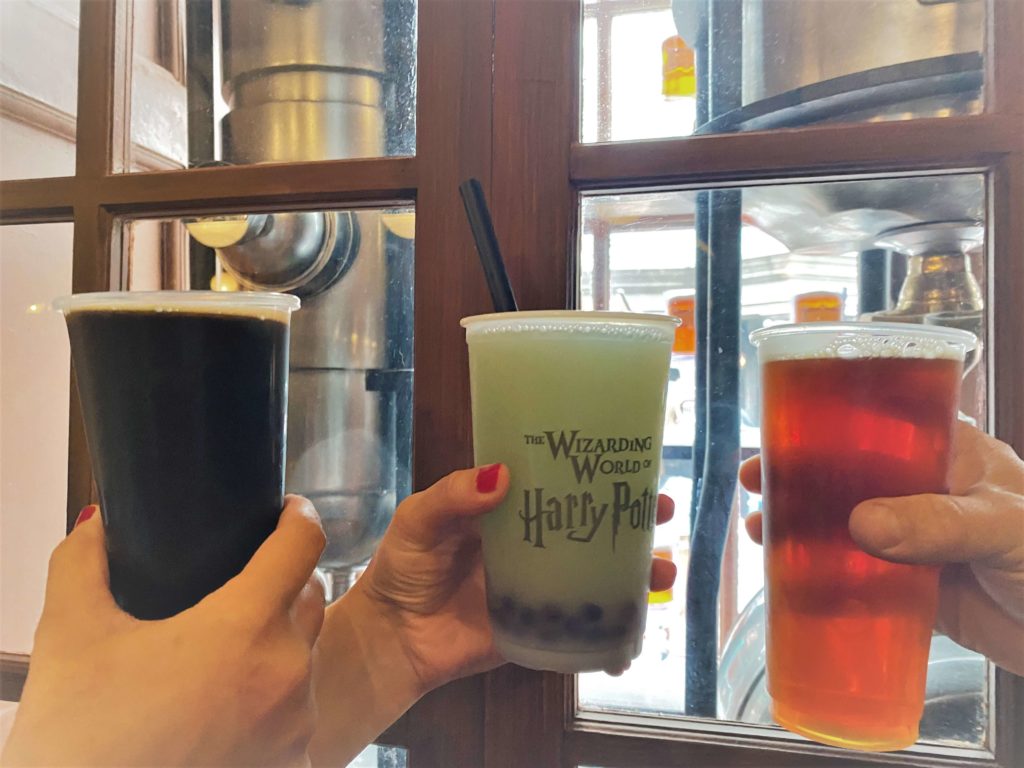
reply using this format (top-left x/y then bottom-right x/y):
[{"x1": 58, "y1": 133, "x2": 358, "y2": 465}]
[{"x1": 309, "y1": 588, "x2": 424, "y2": 766}]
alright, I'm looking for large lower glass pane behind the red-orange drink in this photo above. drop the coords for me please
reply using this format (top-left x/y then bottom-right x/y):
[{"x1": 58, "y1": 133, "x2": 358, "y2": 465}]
[{"x1": 579, "y1": 174, "x2": 990, "y2": 746}]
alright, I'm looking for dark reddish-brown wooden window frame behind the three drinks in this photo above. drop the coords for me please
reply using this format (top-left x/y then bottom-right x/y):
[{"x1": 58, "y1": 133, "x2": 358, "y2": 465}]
[{"x1": 0, "y1": 0, "x2": 1024, "y2": 768}]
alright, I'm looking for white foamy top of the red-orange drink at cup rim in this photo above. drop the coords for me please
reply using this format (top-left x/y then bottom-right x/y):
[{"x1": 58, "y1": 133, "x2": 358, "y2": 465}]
[{"x1": 751, "y1": 323, "x2": 978, "y2": 362}]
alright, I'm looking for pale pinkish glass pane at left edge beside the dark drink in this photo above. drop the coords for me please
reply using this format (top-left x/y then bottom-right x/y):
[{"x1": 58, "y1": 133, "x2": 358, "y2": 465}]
[{"x1": 0, "y1": 219, "x2": 73, "y2": 653}]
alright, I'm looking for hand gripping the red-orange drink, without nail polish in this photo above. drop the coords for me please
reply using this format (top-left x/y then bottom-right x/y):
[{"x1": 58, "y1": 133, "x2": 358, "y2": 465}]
[{"x1": 739, "y1": 422, "x2": 1024, "y2": 675}]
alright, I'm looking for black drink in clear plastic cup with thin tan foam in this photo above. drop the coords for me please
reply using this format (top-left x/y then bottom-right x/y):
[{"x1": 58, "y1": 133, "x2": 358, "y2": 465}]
[{"x1": 61, "y1": 292, "x2": 298, "y2": 618}]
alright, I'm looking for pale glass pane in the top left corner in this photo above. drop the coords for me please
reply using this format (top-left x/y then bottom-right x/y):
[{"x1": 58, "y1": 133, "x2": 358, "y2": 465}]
[{"x1": 0, "y1": 0, "x2": 79, "y2": 179}]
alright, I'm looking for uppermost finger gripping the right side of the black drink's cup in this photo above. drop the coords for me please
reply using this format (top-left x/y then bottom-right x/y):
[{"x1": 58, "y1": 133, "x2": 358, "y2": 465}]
[{"x1": 234, "y1": 496, "x2": 327, "y2": 609}]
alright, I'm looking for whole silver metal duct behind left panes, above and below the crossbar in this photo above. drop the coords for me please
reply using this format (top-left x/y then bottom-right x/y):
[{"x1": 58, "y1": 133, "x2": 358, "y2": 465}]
[{"x1": 188, "y1": 0, "x2": 413, "y2": 587}]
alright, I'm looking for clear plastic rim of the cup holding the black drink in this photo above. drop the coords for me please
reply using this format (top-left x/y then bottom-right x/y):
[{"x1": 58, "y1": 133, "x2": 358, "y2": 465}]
[{"x1": 52, "y1": 291, "x2": 302, "y2": 314}]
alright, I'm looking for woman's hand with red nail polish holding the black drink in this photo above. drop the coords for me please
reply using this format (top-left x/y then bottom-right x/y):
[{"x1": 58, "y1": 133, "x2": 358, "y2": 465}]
[{"x1": 3, "y1": 497, "x2": 325, "y2": 767}]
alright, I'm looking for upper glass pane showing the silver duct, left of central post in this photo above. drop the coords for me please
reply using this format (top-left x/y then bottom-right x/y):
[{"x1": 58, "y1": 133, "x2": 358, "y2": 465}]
[{"x1": 131, "y1": 0, "x2": 416, "y2": 170}]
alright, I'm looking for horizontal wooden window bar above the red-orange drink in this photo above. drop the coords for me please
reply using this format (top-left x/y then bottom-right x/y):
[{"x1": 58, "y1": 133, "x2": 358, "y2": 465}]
[{"x1": 570, "y1": 115, "x2": 1021, "y2": 188}]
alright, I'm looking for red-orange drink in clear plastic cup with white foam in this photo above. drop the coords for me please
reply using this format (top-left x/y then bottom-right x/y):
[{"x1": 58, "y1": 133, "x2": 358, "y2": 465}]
[{"x1": 752, "y1": 324, "x2": 974, "y2": 750}]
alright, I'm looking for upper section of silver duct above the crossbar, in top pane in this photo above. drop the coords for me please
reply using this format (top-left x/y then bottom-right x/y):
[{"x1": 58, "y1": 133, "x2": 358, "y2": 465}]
[{"x1": 220, "y1": 0, "x2": 384, "y2": 163}]
